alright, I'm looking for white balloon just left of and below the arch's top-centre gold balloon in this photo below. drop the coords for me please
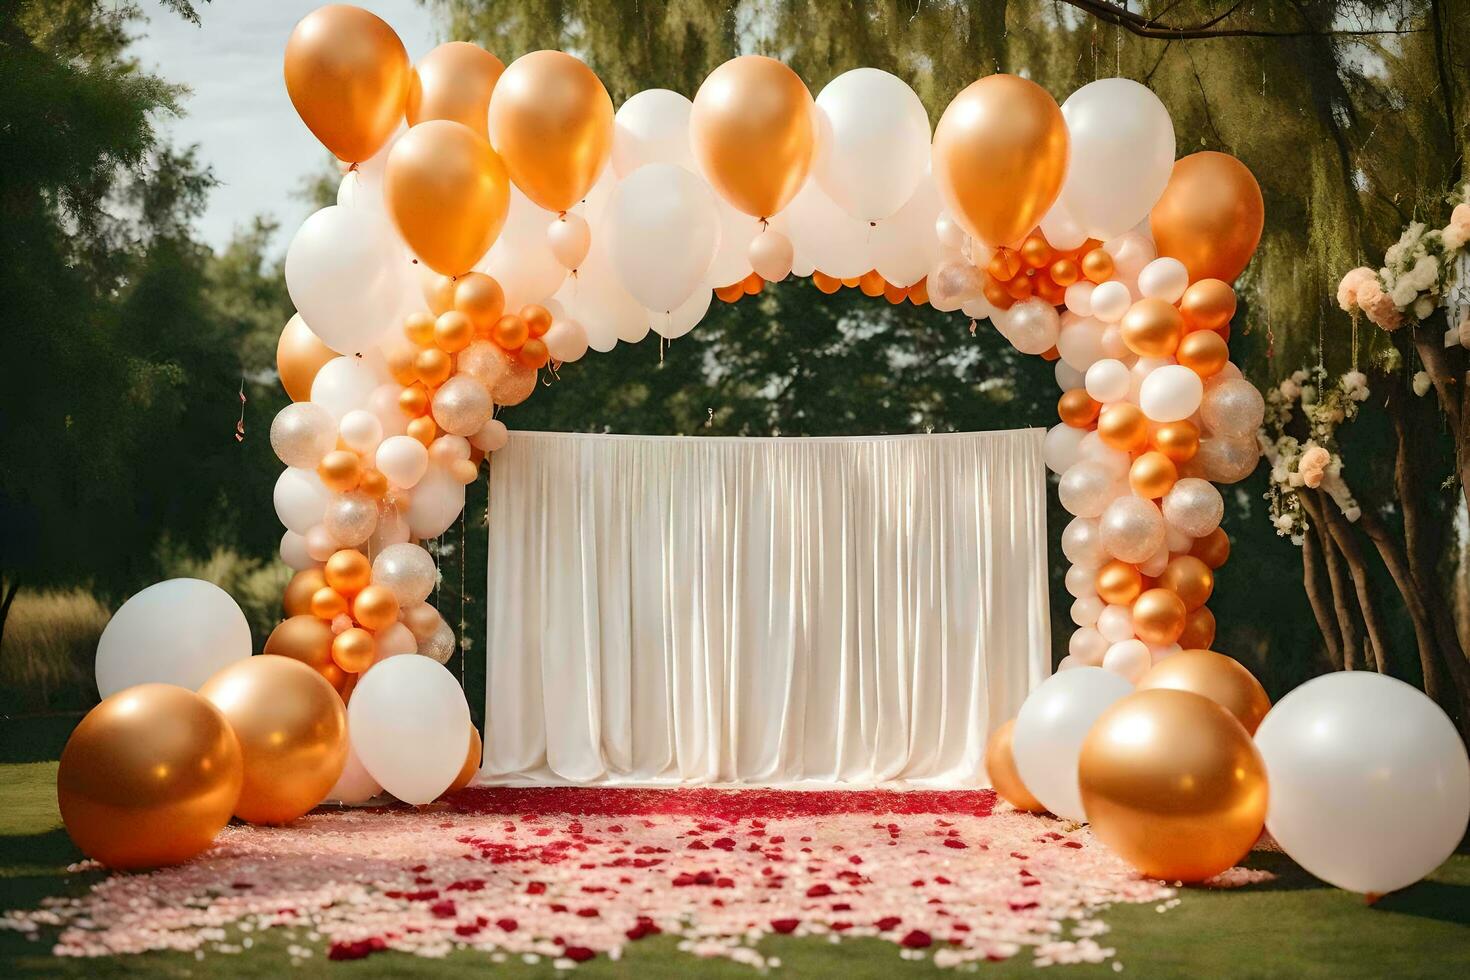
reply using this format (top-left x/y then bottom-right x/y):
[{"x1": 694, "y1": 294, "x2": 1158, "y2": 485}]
[{"x1": 604, "y1": 163, "x2": 720, "y2": 311}]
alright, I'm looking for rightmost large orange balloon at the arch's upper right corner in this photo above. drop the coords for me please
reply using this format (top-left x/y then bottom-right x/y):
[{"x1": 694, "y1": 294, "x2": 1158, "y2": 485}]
[{"x1": 1148, "y1": 150, "x2": 1266, "y2": 282}]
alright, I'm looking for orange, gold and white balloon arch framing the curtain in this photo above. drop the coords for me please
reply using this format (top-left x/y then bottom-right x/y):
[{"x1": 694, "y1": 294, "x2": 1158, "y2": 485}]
[{"x1": 265, "y1": 6, "x2": 1264, "y2": 867}]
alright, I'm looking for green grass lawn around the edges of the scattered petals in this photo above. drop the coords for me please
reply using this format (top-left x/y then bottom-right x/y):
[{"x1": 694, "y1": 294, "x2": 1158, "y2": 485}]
[{"x1": 0, "y1": 763, "x2": 1470, "y2": 980}]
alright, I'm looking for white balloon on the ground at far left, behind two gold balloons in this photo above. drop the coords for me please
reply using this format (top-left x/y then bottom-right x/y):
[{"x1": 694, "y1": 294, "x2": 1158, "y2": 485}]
[{"x1": 97, "y1": 579, "x2": 250, "y2": 698}]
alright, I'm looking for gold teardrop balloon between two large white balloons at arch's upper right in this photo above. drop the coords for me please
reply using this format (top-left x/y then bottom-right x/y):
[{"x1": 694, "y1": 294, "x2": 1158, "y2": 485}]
[{"x1": 933, "y1": 75, "x2": 1070, "y2": 246}]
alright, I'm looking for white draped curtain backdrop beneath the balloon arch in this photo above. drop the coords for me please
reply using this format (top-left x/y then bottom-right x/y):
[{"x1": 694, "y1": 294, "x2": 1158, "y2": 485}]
[{"x1": 479, "y1": 429, "x2": 1051, "y2": 786}]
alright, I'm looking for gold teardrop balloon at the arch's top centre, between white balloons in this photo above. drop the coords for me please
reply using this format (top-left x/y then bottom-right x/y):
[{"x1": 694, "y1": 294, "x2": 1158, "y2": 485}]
[{"x1": 689, "y1": 54, "x2": 817, "y2": 217}]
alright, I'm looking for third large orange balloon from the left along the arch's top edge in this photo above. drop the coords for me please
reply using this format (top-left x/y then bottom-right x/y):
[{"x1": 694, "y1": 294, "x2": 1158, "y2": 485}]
[{"x1": 490, "y1": 51, "x2": 613, "y2": 212}]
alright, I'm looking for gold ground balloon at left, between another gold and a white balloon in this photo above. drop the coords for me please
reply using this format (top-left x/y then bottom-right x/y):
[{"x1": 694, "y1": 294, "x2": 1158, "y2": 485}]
[{"x1": 198, "y1": 654, "x2": 347, "y2": 823}]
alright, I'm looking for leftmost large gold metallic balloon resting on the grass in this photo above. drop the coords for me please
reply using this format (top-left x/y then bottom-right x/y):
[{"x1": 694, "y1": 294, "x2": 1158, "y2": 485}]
[{"x1": 56, "y1": 683, "x2": 244, "y2": 870}]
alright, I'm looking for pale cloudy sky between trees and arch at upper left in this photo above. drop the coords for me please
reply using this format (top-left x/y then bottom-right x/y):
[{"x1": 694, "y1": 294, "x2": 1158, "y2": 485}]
[{"x1": 132, "y1": 0, "x2": 440, "y2": 251}]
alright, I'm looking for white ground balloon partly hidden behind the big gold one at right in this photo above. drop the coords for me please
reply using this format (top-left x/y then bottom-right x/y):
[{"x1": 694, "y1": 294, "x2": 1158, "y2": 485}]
[{"x1": 1017, "y1": 667, "x2": 1133, "y2": 821}]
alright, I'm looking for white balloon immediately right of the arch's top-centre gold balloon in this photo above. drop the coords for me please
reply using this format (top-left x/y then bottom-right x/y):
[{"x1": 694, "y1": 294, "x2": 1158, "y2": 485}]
[{"x1": 811, "y1": 68, "x2": 929, "y2": 222}]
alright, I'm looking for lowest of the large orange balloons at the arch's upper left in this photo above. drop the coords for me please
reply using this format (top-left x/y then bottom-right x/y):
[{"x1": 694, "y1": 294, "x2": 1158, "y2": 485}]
[{"x1": 382, "y1": 119, "x2": 510, "y2": 276}]
